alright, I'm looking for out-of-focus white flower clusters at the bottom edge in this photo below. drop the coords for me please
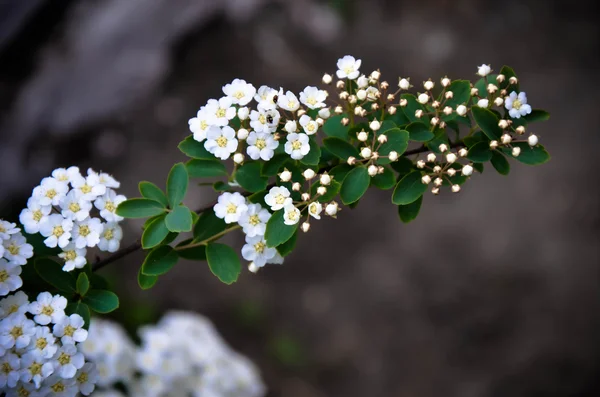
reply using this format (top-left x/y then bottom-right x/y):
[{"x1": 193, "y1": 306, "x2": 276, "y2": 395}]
[{"x1": 82, "y1": 312, "x2": 265, "y2": 397}]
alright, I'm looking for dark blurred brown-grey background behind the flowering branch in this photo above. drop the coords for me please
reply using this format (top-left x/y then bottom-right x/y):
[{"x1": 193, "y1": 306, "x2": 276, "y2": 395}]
[{"x1": 0, "y1": 0, "x2": 600, "y2": 397}]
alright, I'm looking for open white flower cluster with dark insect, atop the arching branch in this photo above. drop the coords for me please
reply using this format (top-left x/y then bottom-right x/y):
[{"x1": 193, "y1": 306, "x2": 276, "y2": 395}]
[{"x1": 189, "y1": 75, "x2": 330, "y2": 164}]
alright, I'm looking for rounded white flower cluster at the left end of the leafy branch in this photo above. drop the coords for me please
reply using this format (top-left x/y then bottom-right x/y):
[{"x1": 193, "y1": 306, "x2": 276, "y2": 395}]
[{"x1": 19, "y1": 167, "x2": 126, "y2": 271}]
